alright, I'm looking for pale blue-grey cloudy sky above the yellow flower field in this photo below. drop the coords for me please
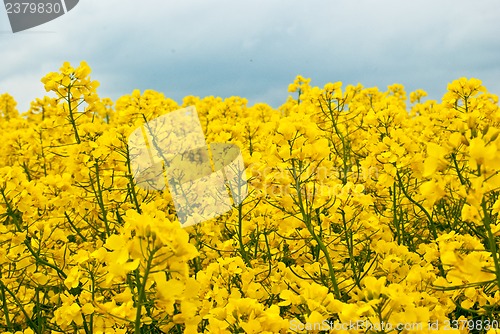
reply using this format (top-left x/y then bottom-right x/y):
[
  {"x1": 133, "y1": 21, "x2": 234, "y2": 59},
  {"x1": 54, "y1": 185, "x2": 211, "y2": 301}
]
[{"x1": 0, "y1": 0, "x2": 500, "y2": 112}]
